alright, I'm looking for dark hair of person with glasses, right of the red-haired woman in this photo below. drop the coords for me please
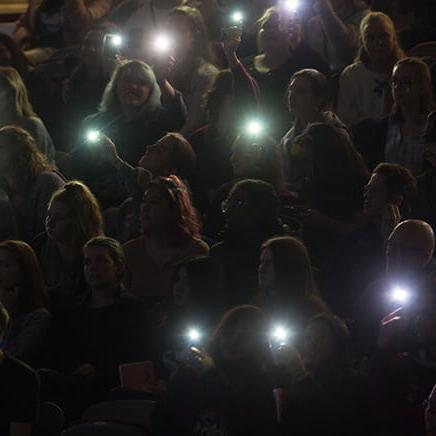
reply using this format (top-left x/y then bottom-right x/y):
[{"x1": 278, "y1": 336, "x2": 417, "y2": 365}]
[{"x1": 227, "y1": 179, "x2": 283, "y2": 237}]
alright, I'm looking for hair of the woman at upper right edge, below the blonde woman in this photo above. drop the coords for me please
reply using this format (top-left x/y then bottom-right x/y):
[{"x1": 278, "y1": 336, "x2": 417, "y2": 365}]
[{"x1": 391, "y1": 57, "x2": 435, "y2": 122}]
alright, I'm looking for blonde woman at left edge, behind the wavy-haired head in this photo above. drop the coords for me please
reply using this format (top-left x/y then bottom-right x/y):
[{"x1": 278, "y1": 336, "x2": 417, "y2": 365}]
[{"x1": 0, "y1": 67, "x2": 55, "y2": 162}]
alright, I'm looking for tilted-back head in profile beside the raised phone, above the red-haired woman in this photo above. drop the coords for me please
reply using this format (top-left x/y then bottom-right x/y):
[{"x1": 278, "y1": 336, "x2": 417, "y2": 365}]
[{"x1": 138, "y1": 132, "x2": 196, "y2": 179}]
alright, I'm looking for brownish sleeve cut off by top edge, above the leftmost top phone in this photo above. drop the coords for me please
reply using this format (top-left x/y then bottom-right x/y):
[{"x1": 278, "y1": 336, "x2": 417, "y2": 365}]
[{"x1": 65, "y1": 0, "x2": 112, "y2": 29}]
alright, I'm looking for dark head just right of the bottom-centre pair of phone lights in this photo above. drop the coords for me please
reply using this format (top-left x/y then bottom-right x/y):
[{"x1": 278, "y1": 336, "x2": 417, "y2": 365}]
[{"x1": 302, "y1": 313, "x2": 351, "y2": 375}]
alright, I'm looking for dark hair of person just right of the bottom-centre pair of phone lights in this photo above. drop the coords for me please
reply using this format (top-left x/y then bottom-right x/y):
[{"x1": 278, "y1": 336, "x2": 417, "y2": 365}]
[{"x1": 308, "y1": 313, "x2": 352, "y2": 370}]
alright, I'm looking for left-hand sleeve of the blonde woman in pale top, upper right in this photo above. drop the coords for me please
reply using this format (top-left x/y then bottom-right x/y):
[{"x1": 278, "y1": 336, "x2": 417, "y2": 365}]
[{"x1": 336, "y1": 68, "x2": 360, "y2": 126}]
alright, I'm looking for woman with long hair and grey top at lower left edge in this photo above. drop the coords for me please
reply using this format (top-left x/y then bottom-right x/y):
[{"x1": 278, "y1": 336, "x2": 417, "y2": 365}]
[{"x1": 0, "y1": 241, "x2": 50, "y2": 364}]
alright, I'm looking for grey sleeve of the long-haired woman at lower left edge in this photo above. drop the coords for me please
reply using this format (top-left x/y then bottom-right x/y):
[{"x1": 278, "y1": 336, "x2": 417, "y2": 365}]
[{"x1": 7, "y1": 312, "x2": 50, "y2": 361}]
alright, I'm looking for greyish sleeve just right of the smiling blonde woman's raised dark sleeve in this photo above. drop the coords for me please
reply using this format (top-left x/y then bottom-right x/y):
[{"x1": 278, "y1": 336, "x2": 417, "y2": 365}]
[{"x1": 180, "y1": 68, "x2": 217, "y2": 136}]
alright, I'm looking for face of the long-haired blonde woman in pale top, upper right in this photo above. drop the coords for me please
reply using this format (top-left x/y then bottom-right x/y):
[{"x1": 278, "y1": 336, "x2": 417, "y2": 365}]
[{"x1": 362, "y1": 20, "x2": 394, "y2": 59}]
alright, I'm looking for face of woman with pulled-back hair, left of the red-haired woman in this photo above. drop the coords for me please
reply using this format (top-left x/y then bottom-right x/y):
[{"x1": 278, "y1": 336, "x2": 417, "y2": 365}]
[{"x1": 83, "y1": 246, "x2": 122, "y2": 289}]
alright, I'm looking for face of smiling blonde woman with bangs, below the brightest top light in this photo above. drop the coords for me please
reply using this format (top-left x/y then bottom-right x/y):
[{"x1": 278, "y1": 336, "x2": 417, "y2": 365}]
[{"x1": 116, "y1": 67, "x2": 150, "y2": 110}]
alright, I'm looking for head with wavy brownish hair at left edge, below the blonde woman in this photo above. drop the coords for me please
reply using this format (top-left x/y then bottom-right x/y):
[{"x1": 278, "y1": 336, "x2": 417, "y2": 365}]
[{"x1": 0, "y1": 126, "x2": 53, "y2": 193}]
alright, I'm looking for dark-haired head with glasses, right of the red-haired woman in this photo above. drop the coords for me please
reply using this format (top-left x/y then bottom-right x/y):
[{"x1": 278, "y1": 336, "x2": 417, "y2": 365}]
[{"x1": 223, "y1": 179, "x2": 282, "y2": 243}]
